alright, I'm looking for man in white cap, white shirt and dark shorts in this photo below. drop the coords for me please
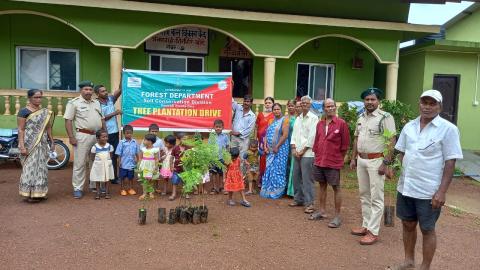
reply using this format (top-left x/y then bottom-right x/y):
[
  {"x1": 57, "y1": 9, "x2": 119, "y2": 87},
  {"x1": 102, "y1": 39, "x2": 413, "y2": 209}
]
[{"x1": 387, "y1": 90, "x2": 463, "y2": 269}]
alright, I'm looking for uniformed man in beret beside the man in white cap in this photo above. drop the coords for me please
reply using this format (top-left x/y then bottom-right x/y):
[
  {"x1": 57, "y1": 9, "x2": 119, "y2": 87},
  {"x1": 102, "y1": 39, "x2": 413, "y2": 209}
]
[{"x1": 350, "y1": 88, "x2": 395, "y2": 245}]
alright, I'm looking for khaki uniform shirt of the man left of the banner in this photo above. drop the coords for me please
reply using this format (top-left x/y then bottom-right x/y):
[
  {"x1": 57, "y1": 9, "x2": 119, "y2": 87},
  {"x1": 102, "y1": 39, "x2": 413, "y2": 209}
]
[{"x1": 63, "y1": 96, "x2": 104, "y2": 131}]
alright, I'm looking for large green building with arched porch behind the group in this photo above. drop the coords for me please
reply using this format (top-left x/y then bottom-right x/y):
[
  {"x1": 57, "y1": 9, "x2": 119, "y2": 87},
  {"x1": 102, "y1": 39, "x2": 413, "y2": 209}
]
[{"x1": 0, "y1": 0, "x2": 436, "y2": 136}]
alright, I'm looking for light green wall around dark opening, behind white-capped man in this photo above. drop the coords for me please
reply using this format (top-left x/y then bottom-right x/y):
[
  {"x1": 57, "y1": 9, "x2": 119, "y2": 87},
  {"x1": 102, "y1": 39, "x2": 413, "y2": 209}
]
[{"x1": 423, "y1": 52, "x2": 480, "y2": 150}]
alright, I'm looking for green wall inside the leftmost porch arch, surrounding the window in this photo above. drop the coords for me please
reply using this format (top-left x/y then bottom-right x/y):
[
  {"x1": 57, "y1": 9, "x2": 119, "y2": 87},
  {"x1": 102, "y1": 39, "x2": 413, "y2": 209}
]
[{"x1": 0, "y1": 15, "x2": 110, "y2": 89}]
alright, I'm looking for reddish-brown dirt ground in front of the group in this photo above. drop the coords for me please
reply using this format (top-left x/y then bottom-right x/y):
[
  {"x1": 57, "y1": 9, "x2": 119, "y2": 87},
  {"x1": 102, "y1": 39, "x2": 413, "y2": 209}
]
[{"x1": 0, "y1": 164, "x2": 480, "y2": 270}]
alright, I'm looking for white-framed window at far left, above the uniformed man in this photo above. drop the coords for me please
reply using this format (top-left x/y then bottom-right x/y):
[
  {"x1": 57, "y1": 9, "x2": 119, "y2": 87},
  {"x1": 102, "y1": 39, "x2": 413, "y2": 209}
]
[{"x1": 16, "y1": 47, "x2": 78, "y2": 91}]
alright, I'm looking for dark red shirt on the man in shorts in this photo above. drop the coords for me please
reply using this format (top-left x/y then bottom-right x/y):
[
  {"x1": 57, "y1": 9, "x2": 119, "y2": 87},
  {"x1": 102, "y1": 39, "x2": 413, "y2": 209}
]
[{"x1": 312, "y1": 116, "x2": 350, "y2": 169}]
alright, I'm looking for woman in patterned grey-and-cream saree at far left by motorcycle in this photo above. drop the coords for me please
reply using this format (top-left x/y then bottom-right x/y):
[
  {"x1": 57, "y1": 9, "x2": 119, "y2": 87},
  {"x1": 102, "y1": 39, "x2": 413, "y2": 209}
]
[{"x1": 17, "y1": 89, "x2": 54, "y2": 202}]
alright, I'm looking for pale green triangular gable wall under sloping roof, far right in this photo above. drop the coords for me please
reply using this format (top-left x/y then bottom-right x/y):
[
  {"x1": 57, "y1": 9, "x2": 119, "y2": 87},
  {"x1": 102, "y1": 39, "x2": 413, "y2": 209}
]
[{"x1": 445, "y1": 9, "x2": 480, "y2": 42}]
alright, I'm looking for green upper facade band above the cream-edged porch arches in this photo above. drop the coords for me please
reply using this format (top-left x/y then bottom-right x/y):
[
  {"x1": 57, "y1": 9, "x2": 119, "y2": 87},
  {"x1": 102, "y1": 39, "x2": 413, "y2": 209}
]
[{"x1": 0, "y1": 1, "x2": 404, "y2": 61}]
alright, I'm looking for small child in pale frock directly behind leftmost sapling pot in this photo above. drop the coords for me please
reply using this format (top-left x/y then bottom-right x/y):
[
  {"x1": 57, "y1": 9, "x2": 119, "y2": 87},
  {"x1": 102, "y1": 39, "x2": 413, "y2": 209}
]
[{"x1": 138, "y1": 134, "x2": 160, "y2": 200}]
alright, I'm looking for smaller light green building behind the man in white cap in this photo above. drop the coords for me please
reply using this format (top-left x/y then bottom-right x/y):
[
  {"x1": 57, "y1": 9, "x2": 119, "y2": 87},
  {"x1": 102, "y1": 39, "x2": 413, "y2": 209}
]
[{"x1": 398, "y1": 3, "x2": 480, "y2": 150}]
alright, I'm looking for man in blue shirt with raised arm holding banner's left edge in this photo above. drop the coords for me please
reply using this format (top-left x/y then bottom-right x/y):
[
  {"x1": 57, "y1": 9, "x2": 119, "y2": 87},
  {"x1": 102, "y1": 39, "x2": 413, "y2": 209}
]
[{"x1": 94, "y1": 85, "x2": 122, "y2": 184}]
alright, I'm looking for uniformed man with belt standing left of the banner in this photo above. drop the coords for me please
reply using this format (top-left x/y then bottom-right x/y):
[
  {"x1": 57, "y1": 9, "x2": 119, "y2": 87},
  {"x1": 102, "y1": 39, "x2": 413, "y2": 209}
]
[{"x1": 63, "y1": 81, "x2": 105, "y2": 199}]
